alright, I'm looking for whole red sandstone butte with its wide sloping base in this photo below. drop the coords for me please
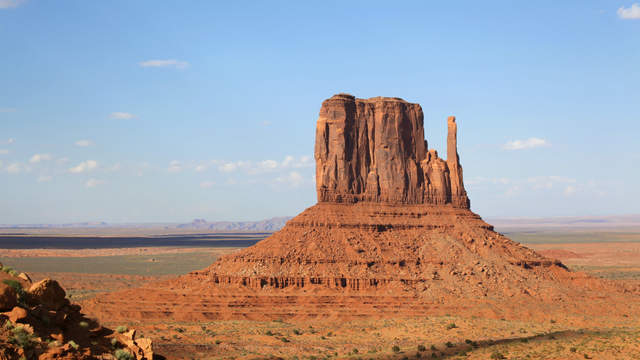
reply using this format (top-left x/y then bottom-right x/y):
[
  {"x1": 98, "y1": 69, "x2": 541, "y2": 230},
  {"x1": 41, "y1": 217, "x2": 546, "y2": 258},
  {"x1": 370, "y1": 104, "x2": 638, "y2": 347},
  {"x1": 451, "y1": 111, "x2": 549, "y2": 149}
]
[{"x1": 85, "y1": 94, "x2": 624, "y2": 321}]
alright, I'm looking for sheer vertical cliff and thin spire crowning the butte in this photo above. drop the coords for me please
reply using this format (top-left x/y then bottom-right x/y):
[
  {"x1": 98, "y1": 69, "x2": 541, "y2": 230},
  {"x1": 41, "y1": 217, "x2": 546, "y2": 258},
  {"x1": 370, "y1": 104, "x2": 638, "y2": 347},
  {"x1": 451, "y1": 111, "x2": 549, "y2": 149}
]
[{"x1": 315, "y1": 94, "x2": 469, "y2": 209}]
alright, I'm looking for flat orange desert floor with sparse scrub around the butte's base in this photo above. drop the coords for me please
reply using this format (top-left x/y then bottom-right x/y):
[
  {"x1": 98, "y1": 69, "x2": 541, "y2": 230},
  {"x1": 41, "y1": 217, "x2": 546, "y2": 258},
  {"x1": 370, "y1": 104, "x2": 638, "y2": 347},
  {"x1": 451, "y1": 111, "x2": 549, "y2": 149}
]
[{"x1": 0, "y1": 228, "x2": 640, "y2": 359}]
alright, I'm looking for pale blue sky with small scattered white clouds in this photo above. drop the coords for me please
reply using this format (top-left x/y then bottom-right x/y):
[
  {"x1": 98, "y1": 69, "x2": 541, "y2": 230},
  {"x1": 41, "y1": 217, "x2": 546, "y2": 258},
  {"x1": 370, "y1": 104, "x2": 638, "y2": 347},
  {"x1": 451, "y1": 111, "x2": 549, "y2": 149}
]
[{"x1": 0, "y1": 0, "x2": 640, "y2": 224}]
